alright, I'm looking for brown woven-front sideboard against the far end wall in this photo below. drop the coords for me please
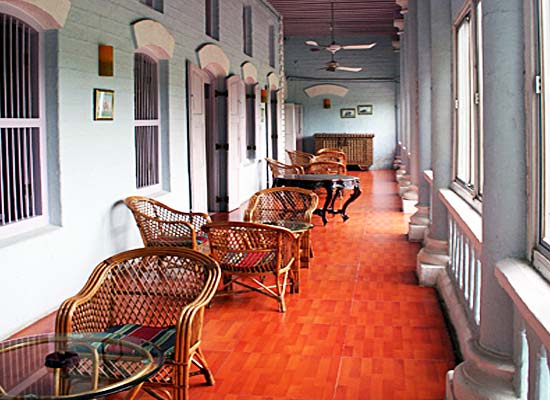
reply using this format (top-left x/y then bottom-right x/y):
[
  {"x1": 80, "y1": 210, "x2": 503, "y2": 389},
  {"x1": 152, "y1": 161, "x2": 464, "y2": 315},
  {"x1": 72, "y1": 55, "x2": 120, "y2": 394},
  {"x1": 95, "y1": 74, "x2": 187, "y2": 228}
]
[{"x1": 313, "y1": 133, "x2": 374, "y2": 169}]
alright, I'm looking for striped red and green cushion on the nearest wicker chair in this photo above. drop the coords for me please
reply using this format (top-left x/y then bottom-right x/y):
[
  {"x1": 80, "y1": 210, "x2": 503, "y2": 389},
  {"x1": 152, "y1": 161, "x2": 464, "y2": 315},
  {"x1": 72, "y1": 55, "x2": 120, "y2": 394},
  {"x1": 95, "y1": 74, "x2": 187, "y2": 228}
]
[{"x1": 105, "y1": 324, "x2": 176, "y2": 359}]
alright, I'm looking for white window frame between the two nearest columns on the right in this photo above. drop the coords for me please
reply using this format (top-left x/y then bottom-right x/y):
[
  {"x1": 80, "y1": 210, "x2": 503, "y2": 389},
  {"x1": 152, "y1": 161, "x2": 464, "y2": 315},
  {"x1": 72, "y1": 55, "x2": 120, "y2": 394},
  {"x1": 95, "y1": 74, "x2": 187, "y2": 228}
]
[{"x1": 451, "y1": 0, "x2": 483, "y2": 213}]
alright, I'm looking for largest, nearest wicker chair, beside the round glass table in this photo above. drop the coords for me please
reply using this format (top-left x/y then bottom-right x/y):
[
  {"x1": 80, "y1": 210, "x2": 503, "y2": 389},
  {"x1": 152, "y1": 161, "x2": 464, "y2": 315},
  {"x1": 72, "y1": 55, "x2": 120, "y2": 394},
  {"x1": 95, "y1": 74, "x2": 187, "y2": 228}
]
[{"x1": 55, "y1": 247, "x2": 221, "y2": 400}]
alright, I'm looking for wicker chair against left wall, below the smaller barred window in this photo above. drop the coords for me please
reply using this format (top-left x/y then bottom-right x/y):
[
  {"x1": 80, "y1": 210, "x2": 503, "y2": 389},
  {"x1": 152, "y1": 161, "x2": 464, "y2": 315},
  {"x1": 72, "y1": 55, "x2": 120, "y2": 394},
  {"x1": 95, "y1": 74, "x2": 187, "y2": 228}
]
[{"x1": 124, "y1": 196, "x2": 212, "y2": 253}]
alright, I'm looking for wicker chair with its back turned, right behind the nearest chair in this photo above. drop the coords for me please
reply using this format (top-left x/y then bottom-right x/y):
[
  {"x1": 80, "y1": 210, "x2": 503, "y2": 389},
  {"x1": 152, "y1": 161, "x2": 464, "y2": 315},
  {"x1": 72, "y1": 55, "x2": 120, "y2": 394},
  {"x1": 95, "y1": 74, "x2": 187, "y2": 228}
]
[{"x1": 203, "y1": 221, "x2": 296, "y2": 312}]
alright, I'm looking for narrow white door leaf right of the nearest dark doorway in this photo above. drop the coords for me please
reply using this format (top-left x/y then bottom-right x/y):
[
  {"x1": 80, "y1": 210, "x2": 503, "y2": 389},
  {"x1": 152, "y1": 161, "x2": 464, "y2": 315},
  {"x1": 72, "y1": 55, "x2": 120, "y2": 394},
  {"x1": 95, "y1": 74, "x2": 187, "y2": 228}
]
[{"x1": 226, "y1": 76, "x2": 246, "y2": 211}]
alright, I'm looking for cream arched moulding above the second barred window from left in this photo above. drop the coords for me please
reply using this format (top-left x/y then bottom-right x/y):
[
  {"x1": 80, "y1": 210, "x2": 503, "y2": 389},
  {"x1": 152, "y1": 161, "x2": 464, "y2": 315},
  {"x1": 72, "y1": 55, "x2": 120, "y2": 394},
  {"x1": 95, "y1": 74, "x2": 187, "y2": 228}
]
[{"x1": 132, "y1": 19, "x2": 175, "y2": 60}]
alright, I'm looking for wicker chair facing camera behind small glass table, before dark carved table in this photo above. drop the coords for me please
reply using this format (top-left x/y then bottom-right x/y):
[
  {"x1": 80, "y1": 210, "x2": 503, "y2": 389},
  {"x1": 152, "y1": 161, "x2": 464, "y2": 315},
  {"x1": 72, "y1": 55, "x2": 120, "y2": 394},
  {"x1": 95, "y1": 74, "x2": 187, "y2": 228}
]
[{"x1": 244, "y1": 187, "x2": 319, "y2": 282}]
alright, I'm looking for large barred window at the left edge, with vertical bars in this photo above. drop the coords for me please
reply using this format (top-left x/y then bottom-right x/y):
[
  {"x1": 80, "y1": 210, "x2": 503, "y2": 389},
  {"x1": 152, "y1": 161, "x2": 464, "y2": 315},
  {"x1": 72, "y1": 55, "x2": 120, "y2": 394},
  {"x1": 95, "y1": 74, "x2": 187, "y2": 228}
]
[{"x1": 0, "y1": 13, "x2": 46, "y2": 227}]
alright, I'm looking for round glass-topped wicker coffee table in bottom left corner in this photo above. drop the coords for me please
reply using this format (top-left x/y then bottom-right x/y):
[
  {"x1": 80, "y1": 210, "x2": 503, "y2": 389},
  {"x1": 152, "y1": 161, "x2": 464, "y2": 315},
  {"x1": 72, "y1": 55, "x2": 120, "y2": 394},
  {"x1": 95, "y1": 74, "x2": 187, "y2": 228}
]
[{"x1": 0, "y1": 333, "x2": 164, "y2": 400}]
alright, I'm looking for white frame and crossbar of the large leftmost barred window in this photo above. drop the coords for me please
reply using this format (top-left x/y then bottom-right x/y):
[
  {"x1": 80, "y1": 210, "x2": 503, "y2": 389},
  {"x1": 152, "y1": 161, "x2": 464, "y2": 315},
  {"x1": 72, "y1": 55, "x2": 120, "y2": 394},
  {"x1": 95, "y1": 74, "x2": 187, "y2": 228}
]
[{"x1": 0, "y1": 9, "x2": 50, "y2": 239}]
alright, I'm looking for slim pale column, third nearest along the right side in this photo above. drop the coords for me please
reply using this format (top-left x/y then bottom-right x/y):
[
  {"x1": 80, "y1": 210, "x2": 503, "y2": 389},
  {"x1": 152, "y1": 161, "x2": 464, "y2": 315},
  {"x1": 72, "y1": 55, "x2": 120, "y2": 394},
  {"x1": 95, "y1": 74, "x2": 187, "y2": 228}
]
[{"x1": 408, "y1": 1, "x2": 432, "y2": 242}]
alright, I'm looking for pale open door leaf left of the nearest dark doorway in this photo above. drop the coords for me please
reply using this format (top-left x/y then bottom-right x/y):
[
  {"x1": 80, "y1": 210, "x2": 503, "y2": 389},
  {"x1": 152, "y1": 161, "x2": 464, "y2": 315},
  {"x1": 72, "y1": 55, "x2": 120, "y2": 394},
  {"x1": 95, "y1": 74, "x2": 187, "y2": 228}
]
[{"x1": 187, "y1": 62, "x2": 208, "y2": 212}]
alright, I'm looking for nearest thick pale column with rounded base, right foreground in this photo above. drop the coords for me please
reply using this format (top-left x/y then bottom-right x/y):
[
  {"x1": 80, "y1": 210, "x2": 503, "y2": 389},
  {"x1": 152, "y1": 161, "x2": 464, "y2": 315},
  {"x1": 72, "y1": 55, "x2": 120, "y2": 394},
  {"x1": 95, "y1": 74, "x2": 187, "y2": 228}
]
[{"x1": 452, "y1": 0, "x2": 528, "y2": 400}]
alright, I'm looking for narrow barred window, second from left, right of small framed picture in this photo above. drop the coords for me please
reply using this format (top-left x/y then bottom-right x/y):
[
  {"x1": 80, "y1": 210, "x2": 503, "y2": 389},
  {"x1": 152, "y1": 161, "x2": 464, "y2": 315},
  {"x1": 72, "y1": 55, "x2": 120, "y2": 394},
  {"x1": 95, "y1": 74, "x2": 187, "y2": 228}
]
[{"x1": 134, "y1": 53, "x2": 160, "y2": 190}]
